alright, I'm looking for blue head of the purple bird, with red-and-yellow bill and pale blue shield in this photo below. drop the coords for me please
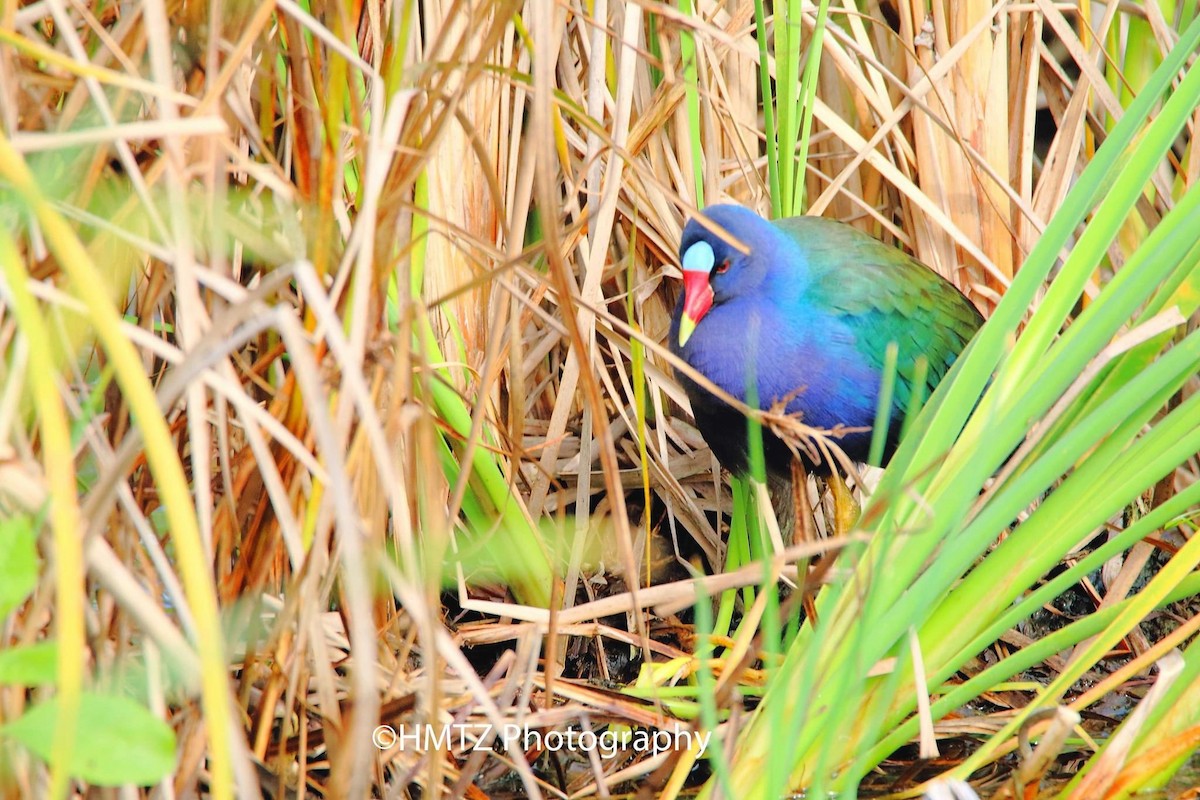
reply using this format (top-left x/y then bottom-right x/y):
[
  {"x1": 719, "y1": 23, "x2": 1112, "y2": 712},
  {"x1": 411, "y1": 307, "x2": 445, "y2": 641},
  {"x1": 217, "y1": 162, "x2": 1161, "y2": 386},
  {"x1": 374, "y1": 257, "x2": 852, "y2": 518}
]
[{"x1": 679, "y1": 205, "x2": 775, "y2": 347}]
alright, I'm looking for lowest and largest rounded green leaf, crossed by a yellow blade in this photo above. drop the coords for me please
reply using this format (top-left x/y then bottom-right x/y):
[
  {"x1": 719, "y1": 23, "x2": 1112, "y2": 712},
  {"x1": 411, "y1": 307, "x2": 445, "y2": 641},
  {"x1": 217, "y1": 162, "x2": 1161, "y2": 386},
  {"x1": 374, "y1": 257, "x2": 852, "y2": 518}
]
[{"x1": 0, "y1": 692, "x2": 175, "y2": 786}]
